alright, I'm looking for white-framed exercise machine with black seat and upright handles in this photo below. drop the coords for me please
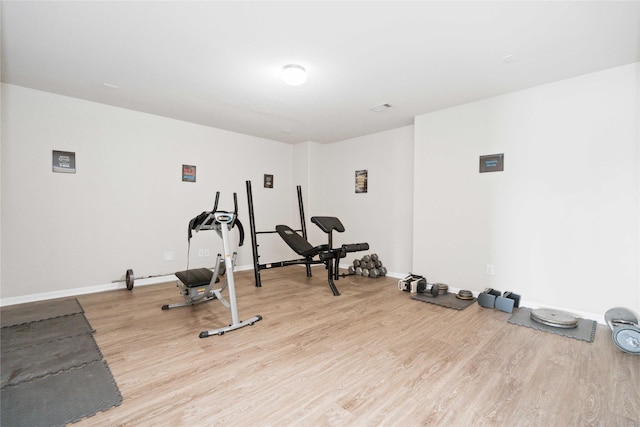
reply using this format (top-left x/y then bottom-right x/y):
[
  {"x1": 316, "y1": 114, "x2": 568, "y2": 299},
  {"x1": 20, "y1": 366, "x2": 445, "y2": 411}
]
[{"x1": 162, "y1": 191, "x2": 262, "y2": 338}]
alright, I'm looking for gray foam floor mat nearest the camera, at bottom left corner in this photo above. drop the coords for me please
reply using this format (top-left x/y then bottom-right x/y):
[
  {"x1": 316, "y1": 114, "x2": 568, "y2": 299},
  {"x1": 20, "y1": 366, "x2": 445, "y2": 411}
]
[{"x1": 0, "y1": 361, "x2": 122, "y2": 427}]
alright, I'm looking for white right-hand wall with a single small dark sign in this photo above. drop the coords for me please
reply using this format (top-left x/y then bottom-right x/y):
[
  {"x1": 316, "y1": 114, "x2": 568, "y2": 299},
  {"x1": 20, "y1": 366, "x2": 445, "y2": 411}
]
[{"x1": 413, "y1": 64, "x2": 640, "y2": 316}]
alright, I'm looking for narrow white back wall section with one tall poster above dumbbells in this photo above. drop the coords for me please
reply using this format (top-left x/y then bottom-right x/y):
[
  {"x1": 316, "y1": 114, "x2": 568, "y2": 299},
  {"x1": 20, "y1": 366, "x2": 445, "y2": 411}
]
[{"x1": 320, "y1": 126, "x2": 420, "y2": 276}]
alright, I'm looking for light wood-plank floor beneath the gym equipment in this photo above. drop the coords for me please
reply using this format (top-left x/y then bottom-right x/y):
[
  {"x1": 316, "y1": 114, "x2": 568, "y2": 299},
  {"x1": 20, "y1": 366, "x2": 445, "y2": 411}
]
[{"x1": 67, "y1": 267, "x2": 640, "y2": 426}]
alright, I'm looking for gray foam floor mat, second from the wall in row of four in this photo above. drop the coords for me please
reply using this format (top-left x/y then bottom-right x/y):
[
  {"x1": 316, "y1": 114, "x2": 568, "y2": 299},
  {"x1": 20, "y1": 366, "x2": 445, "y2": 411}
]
[{"x1": 0, "y1": 313, "x2": 94, "y2": 353}]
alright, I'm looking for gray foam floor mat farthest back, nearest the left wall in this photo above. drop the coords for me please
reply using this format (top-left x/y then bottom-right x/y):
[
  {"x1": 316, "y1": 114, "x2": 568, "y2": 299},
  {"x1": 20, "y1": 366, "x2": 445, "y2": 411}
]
[{"x1": 0, "y1": 298, "x2": 83, "y2": 332}]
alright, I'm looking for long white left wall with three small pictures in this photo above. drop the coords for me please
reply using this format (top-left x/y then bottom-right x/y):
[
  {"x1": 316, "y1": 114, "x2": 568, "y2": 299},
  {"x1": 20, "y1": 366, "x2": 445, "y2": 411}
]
[{"x1": 1, "y1": 85, "x2": 294, "y2": 303}]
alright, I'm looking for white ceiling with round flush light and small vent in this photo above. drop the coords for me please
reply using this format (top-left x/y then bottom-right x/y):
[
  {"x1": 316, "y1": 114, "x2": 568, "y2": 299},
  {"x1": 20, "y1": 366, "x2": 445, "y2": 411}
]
[{"x1": 2, "y1": 1, "x2": 640, "y2": 143}]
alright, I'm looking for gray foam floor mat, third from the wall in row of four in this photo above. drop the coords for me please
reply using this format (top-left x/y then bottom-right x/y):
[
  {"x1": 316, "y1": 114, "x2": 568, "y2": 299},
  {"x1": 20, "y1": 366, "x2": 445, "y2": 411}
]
[{"x1": 0, "y1": 334, "x2": 102, "y2": 388}]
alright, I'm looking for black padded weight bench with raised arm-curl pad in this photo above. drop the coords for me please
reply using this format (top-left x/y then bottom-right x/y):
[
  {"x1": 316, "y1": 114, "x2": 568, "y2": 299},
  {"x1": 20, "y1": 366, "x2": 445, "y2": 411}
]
[{"x1": 276, "y1": 216, "x2": 369, "y2": 296}]
